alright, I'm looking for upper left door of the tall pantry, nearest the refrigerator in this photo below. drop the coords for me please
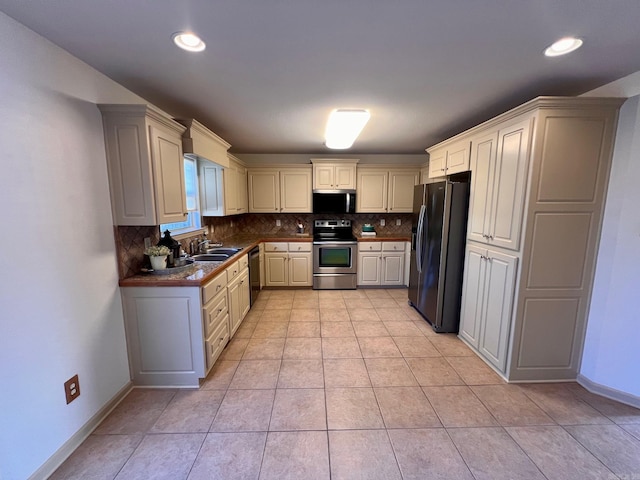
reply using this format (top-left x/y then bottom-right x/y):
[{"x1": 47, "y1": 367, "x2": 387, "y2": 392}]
[{"x1": 467, "y1": 132, "x2": 498, "y2": 243}]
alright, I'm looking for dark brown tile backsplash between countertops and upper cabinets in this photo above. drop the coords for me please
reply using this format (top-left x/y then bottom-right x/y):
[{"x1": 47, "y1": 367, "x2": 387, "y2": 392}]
[{"x1": 114, "y1": 213, "x2": 411, "y2": 278}]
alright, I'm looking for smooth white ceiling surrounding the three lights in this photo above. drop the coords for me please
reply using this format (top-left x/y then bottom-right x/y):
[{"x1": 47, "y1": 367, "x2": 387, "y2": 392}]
[{"x1": 0, "y1": 0, "x2": 640, "y2": 154}]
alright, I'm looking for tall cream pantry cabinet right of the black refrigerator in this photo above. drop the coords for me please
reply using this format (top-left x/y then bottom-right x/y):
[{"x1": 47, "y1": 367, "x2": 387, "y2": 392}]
[{"x1": 444, "y1": 97, "x2": 622, "y2": 381}]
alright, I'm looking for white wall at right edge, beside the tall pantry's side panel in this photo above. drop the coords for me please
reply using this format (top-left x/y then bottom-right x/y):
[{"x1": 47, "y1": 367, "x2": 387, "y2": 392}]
[{"x1": 580, "y1": 72, "x2": 640, "y2": 403}]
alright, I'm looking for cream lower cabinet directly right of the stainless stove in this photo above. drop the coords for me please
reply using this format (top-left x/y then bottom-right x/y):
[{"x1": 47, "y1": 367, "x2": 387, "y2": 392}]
[{"x1": 357, "y1": 242, "x2": 406, "y2": 286}]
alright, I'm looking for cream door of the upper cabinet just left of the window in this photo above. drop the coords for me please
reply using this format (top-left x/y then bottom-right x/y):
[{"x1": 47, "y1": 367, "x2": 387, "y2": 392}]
[{"x1": 149, "y1": 125, "x2": 187, "y2": 224}]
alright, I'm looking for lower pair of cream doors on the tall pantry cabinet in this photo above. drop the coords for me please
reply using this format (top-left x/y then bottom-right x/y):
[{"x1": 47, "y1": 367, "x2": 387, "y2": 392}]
[{"x1": 459, "y1": 245, "x2": 518, "y2": 372}]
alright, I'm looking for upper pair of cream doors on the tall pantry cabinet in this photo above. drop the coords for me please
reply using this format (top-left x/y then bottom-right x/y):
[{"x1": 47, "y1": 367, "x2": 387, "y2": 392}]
[{"x1": 467, "y1": 118, "x2": 532, "y2": 250}]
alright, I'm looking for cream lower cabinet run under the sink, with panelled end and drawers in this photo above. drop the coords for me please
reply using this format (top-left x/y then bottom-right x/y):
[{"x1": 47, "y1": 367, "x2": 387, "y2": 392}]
[{"x1": 121, "y1": 255, "x2": 250, "y2": 387}]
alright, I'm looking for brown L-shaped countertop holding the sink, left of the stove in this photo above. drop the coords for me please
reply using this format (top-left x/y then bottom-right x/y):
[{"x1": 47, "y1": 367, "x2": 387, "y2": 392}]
[{"x1": 119, "y1": 233, "x2": 312, "y2": 287}]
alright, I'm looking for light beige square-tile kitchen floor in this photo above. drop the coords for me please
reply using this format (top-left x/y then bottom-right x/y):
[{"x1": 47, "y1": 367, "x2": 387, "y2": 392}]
[{"x1": 52, "y1": 289, "x2": 640, "y2": 480}]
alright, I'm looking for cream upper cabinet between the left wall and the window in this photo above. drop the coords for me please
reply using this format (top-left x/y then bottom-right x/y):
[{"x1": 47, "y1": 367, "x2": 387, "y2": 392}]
[{"x1": 99, "y1": 105, "x2": 187, "y2": 225}]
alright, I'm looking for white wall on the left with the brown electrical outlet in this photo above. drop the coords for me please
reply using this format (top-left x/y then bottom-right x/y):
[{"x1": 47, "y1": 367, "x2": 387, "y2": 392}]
[{"x1": 0, "y1": 13, "x2": 141, "y2": 480}]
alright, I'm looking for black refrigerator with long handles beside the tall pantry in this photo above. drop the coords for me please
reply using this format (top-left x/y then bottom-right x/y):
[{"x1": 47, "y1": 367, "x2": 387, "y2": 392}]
[{"x1": 409, "y1": 175, "x2": 469, "y2": 333}]
